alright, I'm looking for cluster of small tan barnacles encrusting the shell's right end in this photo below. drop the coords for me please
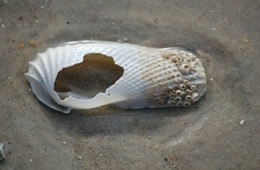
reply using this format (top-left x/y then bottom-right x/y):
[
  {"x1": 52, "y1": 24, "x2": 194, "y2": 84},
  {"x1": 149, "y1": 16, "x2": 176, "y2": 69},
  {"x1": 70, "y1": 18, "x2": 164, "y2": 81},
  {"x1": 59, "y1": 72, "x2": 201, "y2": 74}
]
[{"x1": 155, "y1": 51, "x2": 199, "y2": 107}]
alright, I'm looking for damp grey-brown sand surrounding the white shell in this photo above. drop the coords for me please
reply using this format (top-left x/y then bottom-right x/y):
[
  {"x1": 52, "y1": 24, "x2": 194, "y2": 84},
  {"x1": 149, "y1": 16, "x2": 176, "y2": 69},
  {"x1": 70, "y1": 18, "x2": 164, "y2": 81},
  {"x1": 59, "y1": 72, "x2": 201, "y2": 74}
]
[{"x1": 0, "y1": 0, "x2": 260, "y2": 170}]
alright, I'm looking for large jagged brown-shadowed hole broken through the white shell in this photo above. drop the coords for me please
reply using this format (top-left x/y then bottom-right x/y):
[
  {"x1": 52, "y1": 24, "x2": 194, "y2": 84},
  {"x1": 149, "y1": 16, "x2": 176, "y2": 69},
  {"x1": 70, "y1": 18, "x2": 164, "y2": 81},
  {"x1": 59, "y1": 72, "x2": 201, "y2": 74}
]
[{"x1": 54, "y1": 53, "x2": 124, "y2": 99}]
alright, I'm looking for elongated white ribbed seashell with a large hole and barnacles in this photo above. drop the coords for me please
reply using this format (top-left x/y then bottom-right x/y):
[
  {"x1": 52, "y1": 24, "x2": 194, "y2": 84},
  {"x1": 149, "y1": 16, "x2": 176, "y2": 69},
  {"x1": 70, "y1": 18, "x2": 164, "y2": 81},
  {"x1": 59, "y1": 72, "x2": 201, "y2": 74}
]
[{"x1": 25, "y1": 41, "x2": 206, "y2": 113}]
